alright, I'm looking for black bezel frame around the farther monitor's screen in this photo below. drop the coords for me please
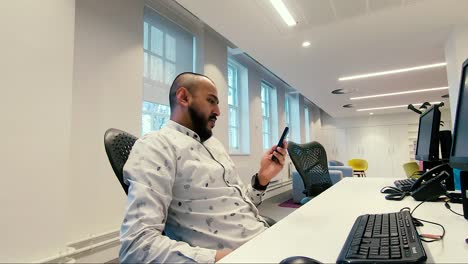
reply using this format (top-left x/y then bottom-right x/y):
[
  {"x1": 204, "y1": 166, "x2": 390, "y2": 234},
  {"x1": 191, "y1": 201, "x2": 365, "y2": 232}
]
[{"x1": 415, "y1": 105, "x2": 441, "y2": 161}]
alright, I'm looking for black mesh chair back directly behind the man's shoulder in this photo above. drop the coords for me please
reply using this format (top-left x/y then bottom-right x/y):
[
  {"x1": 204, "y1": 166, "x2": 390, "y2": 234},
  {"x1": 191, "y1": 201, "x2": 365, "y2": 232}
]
[{"x1": 104, "y1": 128, "x2": 138, "y2": 194}]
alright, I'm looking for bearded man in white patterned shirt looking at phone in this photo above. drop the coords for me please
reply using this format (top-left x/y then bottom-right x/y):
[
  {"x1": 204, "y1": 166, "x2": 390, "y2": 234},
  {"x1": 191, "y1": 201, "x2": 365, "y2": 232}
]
[{"x1": 120, "y1": 73, "x2": 287, "y2": 263}]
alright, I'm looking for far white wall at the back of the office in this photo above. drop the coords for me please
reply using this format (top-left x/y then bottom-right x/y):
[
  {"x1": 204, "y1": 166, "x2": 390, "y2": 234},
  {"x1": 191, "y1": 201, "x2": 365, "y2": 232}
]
[{"x1": 318, "y1": 109, "x2": 451, "y2": 177}]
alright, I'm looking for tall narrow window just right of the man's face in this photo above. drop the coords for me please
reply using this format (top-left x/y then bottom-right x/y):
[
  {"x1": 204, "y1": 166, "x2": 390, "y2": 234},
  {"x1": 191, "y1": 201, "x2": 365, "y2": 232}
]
[{"x1": 227, "y1": 58, "x2": 250, "y2": 154}]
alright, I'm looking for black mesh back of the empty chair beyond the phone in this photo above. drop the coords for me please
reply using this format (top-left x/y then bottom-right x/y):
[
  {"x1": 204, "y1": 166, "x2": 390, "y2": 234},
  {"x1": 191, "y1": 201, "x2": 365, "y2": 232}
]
[{"x1": 288, "y1": 141, "x2": 333, "y2": 197}]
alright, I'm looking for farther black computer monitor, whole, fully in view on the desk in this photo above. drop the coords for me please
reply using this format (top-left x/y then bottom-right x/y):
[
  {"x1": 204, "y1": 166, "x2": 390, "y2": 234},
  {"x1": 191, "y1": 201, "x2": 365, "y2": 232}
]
[{"x1": 416, "y1": 105, "x2": 440, "y2": 161}]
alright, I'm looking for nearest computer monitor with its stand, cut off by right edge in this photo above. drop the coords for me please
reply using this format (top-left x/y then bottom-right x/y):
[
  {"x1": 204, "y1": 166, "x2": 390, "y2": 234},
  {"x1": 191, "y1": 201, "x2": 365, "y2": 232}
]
[{"x1": 450, "y1": 59, "x2": 468, "y2": 219}]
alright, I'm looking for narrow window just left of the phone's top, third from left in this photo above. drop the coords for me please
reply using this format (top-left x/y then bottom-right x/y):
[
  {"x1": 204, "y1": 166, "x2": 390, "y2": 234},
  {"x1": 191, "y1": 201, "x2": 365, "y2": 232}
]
[{"x1": 260, "y1": 82, "x2": 278, "y2": 149}]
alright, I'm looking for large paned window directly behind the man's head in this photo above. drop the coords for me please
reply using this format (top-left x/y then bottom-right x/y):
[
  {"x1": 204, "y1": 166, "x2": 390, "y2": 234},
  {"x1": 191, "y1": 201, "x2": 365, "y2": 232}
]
[{"x1": 141, "y1": 7, "x2": 195, "y2": 134}]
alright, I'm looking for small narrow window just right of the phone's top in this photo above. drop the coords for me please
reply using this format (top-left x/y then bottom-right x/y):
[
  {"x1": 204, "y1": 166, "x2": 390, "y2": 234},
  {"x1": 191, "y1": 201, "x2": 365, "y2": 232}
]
[{"x1": 284, "y1": 92, "x2": 301, "y2": 143}]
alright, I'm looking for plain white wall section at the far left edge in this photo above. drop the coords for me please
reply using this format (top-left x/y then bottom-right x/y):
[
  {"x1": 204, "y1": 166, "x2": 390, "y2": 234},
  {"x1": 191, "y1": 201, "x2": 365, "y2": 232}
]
[{"x1": 0, "y1": 0, "x2": 75, "y2": 262}]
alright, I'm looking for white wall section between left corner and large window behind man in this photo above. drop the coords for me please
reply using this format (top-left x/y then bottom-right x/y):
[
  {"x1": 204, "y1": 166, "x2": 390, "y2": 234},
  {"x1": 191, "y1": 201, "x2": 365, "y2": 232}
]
[{"x1": 69, "y1": 0, "x2": 144, "y2": 244}]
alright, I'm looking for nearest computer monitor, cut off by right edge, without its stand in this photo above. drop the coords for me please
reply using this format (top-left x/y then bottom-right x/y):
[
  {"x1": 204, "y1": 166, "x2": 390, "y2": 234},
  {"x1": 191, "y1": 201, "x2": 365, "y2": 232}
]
[{"x1": 450, "y1": 59, "x2": 468, "y2": 171}]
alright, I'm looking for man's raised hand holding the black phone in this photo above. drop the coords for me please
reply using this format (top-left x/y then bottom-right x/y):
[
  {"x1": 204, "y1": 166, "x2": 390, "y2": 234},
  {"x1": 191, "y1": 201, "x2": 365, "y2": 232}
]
[{"x1": 258, "y1": 140, "x2": 288, "y2": 186}]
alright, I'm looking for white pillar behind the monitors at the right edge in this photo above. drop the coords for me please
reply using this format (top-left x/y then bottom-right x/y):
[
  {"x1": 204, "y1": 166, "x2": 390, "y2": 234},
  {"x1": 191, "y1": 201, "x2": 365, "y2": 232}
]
[{"x1": 445, "y1": 25, "x2": 468, "y2": 128}]
